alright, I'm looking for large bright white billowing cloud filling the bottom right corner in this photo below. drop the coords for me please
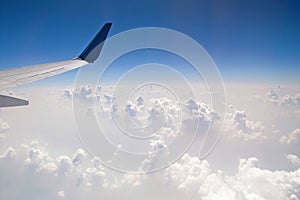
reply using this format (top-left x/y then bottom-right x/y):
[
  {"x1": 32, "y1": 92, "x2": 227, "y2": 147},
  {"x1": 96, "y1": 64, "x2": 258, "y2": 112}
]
[{"x1": 165, "y1": 154, "x2": 300, "y2": 200}]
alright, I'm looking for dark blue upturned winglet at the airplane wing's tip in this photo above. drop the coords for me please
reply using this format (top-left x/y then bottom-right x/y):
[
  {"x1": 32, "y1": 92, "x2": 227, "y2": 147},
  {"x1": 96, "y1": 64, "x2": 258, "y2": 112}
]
[{"x1": 77, "y1": 23, "x2": 112, "y2": 63}]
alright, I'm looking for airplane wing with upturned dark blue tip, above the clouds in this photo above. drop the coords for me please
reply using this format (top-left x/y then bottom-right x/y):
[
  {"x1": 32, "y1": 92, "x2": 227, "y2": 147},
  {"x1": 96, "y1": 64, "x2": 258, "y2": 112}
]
[{"x1": 0, "y1": 23, "x2": 112, "y2": 107}]
